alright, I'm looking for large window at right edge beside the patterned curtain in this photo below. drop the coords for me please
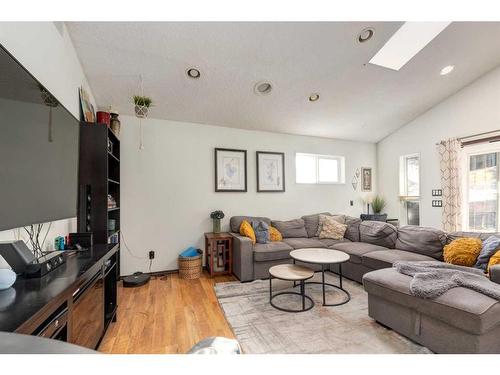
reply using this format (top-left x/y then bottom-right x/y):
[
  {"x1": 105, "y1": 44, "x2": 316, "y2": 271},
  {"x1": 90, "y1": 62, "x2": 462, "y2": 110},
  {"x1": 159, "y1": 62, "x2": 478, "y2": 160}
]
[{"x1": 462, "y1": 143, "x2": 500, "y2": 232}]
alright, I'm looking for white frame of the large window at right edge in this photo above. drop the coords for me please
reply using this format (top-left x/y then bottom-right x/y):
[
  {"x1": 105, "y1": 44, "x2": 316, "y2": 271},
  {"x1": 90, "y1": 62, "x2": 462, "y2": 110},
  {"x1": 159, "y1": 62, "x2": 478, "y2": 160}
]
[{"x1": 460, "y1": 142, "x2": 500, "y2": 233}]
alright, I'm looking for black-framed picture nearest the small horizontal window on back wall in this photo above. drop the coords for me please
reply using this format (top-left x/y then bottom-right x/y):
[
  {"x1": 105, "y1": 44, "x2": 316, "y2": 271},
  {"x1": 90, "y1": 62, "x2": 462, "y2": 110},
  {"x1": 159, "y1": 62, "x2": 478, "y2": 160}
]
[{"x1": 256, "y1": 151, "x2": 285, "y2": 193}]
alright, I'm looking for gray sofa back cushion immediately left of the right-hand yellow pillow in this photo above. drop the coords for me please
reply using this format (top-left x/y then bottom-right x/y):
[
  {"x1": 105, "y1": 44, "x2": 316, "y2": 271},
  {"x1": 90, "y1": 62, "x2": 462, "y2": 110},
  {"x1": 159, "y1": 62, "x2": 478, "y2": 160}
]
[{"x1": 396, "y1": 225, "x2": 447, "y2": 260}]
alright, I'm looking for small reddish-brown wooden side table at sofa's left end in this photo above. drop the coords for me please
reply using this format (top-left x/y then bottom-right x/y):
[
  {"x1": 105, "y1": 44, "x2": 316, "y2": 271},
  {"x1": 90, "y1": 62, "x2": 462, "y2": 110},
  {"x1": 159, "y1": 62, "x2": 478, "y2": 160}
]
[{"x1": 205, "y1": 232, "x2": 233, "y2": 276}]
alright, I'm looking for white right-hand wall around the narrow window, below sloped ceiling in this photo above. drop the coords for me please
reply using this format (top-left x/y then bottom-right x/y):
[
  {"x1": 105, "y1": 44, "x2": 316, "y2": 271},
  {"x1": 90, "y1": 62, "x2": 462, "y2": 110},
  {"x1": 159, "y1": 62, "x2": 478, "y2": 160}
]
[{"x1": 377, "y1": 68, "x2": 500, "y2": 228}]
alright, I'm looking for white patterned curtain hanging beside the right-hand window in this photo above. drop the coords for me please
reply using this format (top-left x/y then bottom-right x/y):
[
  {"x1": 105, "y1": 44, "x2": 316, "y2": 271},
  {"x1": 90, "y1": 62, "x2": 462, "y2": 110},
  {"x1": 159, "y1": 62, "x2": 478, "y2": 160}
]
[{"x1": 438, "y1": 138, "x2": 462, "y2": 232}]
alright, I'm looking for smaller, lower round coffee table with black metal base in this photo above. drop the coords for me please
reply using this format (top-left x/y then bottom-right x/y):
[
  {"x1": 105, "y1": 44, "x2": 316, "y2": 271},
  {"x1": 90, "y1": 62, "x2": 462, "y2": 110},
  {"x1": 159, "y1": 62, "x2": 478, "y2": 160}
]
[{"x1": 269, "y1": 264, "x2": 314, "y2": 312}]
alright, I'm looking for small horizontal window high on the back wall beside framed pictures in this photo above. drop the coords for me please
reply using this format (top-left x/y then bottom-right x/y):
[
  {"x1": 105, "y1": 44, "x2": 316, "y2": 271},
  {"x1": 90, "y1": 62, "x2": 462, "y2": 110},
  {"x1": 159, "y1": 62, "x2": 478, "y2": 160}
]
[{"x1": 295, "y1": 153, "x2": 345, "y2": 184}]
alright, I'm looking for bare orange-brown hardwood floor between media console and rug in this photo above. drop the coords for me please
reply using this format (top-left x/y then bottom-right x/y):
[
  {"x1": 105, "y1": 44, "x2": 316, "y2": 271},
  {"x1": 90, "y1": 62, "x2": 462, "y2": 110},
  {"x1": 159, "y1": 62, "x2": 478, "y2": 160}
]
[{"x1": 99, "y1": 272, "x2": 236, "y2": 354}]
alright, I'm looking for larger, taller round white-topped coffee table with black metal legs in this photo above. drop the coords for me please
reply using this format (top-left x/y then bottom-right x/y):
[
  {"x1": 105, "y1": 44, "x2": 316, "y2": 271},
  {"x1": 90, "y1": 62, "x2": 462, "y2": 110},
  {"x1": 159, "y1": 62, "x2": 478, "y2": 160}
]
[{"x1": 290, "y1": 248, "x2": 351, "y2": 306}]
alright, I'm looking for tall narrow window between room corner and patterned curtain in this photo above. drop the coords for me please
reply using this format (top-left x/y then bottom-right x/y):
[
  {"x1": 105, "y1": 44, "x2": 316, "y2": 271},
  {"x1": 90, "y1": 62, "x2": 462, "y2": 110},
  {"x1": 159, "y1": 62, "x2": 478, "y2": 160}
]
[{"x1": 399, "y1": 154, "x2": 420, "y2": 225}]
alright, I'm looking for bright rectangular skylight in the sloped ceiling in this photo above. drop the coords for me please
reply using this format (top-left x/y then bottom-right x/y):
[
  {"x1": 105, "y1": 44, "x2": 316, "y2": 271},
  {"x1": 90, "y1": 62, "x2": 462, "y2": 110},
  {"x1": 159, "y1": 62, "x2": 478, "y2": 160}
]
[{"x1": 370, "y1": 22, "x2": 451, "y2": 70}]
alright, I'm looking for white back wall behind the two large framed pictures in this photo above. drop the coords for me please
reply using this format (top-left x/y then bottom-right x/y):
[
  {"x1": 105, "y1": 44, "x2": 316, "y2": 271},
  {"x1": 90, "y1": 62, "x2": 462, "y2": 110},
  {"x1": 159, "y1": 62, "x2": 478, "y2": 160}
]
[{"x1": 120, "y1": 116, "x2": 376, "y2": 274}]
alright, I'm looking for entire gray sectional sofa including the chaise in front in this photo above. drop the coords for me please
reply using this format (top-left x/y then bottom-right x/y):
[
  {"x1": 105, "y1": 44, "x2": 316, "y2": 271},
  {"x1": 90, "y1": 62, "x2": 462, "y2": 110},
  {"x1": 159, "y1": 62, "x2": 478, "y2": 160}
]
[{"x1": 230, "y1": 213, "x2": 500, "y2": 353}]
